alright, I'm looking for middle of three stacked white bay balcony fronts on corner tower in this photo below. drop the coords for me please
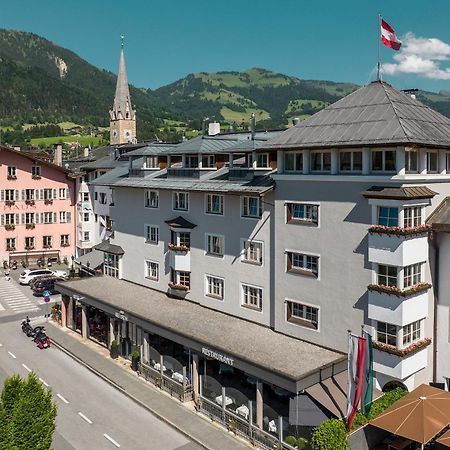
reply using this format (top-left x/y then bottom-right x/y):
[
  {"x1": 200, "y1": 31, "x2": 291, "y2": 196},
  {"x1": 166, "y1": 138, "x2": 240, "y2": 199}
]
[{"x1": 367, "y1": 291, "x2": 429, "y2": 326}]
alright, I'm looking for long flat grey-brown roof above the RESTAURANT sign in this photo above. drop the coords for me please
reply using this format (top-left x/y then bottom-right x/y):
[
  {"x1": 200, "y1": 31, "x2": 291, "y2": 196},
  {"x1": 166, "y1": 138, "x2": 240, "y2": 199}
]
[{"x1": 58, "y1": 276, "x2": 346, "y2": 388}]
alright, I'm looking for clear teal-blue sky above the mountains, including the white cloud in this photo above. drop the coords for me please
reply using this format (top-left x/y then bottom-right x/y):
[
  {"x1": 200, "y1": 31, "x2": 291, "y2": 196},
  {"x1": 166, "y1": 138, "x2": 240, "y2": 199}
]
[{"x1": 0, "y1": 0, "x2": 450, "y2": 91}]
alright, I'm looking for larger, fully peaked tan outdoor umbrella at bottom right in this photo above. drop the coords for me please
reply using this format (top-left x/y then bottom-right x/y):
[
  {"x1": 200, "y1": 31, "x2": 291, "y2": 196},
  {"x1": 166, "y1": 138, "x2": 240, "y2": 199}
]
[{"x1": 370, "y1": 384, "x2": 450, "y2": 444}]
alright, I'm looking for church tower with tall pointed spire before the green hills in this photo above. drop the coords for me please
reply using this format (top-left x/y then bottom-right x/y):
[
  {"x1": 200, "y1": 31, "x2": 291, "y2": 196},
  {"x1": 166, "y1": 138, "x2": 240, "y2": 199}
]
[{"x1": 109, "y1": 36, "x2": 136, "y2": 145}]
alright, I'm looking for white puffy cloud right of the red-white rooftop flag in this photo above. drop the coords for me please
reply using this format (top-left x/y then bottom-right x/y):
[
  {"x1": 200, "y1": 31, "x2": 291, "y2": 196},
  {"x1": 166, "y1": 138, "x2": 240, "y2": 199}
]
[{"x1": 382, "y1": 33, "x2": 450, "y2": 80}]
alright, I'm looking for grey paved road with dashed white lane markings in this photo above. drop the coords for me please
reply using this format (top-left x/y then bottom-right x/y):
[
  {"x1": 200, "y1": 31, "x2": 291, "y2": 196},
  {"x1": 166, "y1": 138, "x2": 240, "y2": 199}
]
[{"x1": 0, "y1": 280, "x2": 199, "y2": 450}]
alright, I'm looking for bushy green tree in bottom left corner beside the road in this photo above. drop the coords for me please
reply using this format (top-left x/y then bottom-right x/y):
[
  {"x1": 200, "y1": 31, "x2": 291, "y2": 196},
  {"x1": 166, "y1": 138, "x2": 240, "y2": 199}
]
[{"x1": 0, "y1": 373, "x2": 56, "y2": 450}]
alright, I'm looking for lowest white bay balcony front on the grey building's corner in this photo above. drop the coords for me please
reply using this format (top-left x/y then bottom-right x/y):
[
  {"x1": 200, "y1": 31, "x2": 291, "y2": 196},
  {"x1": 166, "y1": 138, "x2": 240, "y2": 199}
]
[{"x1": 373, "y1": 340, "x2": 431, "y2": 380}]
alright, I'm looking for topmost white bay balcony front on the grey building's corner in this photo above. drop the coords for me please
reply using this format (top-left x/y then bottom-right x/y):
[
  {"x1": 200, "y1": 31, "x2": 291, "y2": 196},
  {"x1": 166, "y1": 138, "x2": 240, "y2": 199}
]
[{"x1": 368, "y1": 232, "x2": 428, "y2": 267}]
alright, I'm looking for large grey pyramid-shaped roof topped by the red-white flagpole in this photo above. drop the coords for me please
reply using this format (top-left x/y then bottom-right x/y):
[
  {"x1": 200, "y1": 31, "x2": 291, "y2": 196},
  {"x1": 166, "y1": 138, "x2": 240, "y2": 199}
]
[{"x1": 262, "y1": 81, "x2": 450, "y2": 149}]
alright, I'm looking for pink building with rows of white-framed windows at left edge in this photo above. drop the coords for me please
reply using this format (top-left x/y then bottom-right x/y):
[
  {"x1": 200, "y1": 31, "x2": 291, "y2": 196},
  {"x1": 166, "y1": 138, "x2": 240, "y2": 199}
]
[{"x1": 0, "y1": 147, "x2": 76, "y2": 264}]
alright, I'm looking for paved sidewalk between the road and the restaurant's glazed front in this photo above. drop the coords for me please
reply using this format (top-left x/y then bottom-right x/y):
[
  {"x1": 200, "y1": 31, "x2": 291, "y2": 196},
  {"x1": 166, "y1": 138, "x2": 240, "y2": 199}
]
[{"x1": 46, "y1": 322, "x2": 249, "y2": 450}]
